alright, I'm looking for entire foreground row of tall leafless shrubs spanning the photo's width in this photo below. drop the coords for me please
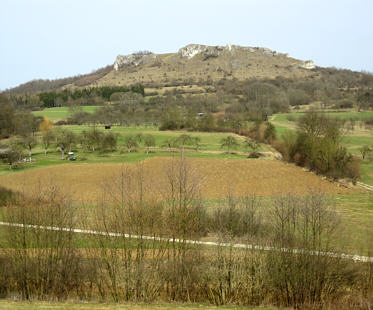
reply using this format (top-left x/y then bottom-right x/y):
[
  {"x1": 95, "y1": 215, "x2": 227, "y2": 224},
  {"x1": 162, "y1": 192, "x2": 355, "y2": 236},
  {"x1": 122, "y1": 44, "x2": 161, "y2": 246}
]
[{"x1": 0, "y1": 160, "x2": 373, "y2": 310}]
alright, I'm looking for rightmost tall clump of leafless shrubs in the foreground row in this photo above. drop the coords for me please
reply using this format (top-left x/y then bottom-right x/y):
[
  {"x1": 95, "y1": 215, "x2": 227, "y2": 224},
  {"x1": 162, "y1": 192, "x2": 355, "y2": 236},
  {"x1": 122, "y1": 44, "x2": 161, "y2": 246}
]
[{"x1": 266, "y1": 195, "x2": 355, "y2": 307}]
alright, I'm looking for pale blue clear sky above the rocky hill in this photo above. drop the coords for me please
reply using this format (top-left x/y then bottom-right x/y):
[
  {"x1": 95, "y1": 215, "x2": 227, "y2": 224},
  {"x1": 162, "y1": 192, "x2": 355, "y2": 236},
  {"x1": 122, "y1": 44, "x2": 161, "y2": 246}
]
[{"x1": 0, "y1": 0, "x2": 373, "y2": 90}]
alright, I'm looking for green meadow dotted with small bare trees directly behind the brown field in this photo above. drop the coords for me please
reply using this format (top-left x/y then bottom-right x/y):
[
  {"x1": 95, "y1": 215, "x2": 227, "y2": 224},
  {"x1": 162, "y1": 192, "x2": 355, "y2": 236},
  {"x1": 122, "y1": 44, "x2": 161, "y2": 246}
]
[{"x1": 0, "y1": 126, "x2": 269, "y2": 175}]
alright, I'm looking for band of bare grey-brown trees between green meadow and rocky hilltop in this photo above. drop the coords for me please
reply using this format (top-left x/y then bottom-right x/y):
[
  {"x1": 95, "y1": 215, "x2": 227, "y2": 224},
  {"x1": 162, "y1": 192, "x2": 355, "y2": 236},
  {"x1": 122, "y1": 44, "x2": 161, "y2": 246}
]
[{"x1": 61, "y1": 78, "x2": 373, "y2": 131}]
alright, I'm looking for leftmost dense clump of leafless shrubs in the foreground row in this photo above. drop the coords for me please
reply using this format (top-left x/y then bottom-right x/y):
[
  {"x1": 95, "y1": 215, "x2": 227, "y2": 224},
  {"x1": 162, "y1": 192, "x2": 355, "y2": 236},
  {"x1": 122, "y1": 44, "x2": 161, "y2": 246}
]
[{"x1": 2, "y1": 186, "x2": 81, "y2": 299}]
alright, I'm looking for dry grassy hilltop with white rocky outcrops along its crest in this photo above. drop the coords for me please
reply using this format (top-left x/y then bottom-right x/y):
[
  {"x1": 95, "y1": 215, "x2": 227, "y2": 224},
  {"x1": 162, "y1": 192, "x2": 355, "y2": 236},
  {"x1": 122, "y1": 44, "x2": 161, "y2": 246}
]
[{"x1": 6, "y1": 44, "x2": 320, "y2": 94}]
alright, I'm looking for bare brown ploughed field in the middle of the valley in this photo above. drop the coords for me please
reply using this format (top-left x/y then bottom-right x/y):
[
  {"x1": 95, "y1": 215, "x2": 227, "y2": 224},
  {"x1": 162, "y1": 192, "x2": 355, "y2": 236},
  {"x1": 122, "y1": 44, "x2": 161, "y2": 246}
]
[{"x1": 0, "y1": 158, "x2": 356, "y2": 202}]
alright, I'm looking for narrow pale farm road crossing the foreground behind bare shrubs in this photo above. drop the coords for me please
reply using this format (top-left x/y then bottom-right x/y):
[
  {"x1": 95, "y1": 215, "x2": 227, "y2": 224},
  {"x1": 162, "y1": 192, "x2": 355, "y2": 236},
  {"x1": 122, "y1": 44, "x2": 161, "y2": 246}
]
[{"x1": 0, "y1": 222, "x2": 373, "y2": 263}]
